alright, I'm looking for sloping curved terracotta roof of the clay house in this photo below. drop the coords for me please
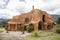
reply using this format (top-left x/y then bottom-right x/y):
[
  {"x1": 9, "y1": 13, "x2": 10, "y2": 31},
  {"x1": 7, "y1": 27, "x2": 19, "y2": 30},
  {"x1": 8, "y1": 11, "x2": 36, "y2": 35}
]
[{"x1": 8, "y1": 8, "x2": 51, "y2": 25}]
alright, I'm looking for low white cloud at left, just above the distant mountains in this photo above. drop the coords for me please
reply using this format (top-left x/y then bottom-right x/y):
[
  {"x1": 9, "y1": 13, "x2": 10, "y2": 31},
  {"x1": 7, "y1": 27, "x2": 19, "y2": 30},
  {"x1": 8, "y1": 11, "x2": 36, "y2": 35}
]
[{"x1": 0, "y1": 9, "x2": 19, "y2": 18}]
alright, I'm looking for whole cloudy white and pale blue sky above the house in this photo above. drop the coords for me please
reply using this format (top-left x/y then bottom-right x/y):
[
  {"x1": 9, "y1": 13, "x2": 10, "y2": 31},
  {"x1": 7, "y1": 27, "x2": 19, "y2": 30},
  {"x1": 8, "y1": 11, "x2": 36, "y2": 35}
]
[{"x1": 0, "y1": 0, "x2": 60, "y2": 18}]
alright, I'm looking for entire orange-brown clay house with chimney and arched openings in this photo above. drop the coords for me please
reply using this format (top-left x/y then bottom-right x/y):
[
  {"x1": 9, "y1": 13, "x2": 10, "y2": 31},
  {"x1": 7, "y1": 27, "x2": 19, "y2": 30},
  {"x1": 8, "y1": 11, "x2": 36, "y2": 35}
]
[{"x1": 8, "y1": 6, "x2": 56, "y2": 31}]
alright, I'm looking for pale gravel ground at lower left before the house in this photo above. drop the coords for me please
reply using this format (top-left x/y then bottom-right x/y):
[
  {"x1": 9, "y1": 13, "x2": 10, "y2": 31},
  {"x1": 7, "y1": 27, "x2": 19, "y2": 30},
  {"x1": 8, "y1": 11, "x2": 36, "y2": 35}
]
[{"x1": 0, "y1": 31, "x2": 31, "y2": 40}]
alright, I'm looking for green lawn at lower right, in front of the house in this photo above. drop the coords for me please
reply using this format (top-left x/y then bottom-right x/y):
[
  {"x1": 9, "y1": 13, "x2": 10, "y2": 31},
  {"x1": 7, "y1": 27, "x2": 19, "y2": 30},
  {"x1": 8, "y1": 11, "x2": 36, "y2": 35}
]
[{"x1": 25, "y1": 24, "x2": 60, "y2": 40}]
